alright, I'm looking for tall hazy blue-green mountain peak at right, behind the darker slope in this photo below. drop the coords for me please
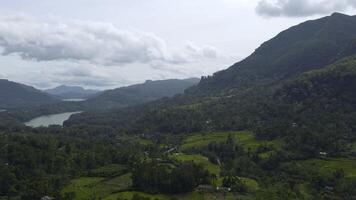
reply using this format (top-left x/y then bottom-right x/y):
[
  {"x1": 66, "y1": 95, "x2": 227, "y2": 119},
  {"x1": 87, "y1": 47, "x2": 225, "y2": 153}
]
[{"x1": 190, "y1": 13, "x2": 356, "y2": 95}]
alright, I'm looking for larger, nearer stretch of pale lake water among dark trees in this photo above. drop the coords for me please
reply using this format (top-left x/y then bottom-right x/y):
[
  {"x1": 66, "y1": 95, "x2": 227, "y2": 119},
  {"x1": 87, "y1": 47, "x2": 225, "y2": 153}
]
[{"x1": 25, "y1": 112, "x2": 81, "y2": 128}]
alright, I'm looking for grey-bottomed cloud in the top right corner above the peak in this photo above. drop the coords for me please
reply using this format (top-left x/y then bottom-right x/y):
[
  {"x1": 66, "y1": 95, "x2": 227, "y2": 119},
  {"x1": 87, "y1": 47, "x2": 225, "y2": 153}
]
[{"x1": 256, "y1": 0, "x2": 356, "y2": 17}]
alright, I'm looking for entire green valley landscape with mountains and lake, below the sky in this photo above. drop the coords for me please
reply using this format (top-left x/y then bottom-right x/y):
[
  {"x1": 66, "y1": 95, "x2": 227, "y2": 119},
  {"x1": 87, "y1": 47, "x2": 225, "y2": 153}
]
[{"x1": 0, "y1": 13, "x2": 356, "y2": 200}]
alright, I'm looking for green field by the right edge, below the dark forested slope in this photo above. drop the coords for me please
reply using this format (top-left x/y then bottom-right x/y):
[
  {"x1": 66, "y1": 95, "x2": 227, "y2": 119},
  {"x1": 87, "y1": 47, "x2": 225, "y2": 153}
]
[{"x1": 303, "y1": 158, "x2": 356, "y2": 178}]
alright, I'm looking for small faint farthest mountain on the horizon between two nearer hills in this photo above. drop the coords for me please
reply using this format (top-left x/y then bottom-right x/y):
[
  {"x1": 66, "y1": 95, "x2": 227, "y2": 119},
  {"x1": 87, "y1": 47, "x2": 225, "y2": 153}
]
[{"x1": 44, "y1": 85, "x2": 99, "y2": 99}]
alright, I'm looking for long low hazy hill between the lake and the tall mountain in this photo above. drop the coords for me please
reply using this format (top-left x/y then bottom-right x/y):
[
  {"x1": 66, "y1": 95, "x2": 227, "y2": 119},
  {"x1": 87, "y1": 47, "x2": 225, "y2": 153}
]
[{"x1": 85, "y1": 78, "x2": 199, "y2": 109}]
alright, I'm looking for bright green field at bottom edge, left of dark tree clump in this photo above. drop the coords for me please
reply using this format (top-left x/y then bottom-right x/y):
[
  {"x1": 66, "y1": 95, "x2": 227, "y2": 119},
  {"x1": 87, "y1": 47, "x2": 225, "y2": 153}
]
[{"x1": 62, "y1": 173, "x2": 132, "y2": 200}]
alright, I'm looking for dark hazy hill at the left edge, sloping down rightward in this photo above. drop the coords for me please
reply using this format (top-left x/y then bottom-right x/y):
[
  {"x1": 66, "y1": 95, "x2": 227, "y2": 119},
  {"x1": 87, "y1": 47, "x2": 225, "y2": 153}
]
[{"x1": 0, "y1": 79, "x2": 59, "y2": 110}]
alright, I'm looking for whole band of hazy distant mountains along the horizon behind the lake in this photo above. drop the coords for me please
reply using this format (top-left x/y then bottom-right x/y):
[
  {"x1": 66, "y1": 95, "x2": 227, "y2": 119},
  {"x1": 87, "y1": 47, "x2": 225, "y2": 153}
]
[{"x1": 0, "y1": 78, "x2": 200, "y2": 111}]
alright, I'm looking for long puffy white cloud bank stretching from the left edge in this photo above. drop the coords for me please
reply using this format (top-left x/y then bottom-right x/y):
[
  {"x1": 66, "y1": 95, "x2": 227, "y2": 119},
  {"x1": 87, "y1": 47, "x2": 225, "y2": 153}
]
[{"x1": 0, "y1": 15, "x2": 219, "y2": 66}]
